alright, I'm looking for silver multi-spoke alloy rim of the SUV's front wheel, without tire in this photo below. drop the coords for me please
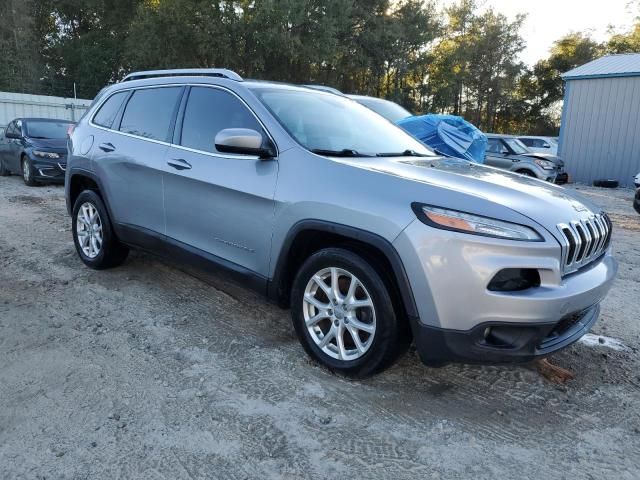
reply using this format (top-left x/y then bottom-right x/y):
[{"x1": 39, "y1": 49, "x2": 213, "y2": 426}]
[{"x1": 303, "y1": 267, "x2": 376, "y2": 360}]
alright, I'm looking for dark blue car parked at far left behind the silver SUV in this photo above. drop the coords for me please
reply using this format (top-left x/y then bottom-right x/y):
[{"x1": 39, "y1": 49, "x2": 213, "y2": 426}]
[{"x1": 0, "y1": 118, "x2": 73, "y2": 186}]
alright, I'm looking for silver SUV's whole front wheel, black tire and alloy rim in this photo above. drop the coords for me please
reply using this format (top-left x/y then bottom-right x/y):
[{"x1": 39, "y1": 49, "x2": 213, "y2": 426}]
[{"x1": 291, "y1": 248, "x2": 404, "y2": 378}]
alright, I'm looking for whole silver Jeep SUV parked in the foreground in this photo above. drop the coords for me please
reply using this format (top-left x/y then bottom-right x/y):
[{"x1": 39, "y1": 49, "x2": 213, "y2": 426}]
[{"x1": 66, "y1": 69, "x2": 617, "y2": 376}]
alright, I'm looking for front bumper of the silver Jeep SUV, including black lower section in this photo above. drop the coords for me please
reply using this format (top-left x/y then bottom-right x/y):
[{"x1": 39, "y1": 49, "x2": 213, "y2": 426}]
[{"x1": 394, "y1": 220, "x2": 617, "y2": 364}]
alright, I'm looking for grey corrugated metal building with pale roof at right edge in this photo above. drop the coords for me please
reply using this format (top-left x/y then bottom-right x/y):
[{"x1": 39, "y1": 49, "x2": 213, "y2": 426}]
[{"x1": 558, "y1": 54, "x2": 640, "y2": 187}]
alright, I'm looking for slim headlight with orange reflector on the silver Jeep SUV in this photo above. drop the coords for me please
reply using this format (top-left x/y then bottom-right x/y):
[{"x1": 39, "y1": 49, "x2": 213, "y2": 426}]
[{"x1": 412, "y1": 203, "x2": 543, "y2": 242}]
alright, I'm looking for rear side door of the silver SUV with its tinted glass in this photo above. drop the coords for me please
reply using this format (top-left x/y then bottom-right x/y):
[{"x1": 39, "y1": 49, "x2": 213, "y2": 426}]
[{"x1": 92, "y1": 86, "x2": 184, "y2": 238}]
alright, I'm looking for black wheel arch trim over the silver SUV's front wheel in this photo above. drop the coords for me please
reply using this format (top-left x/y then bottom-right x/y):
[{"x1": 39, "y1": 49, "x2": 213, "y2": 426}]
[{"x1": 267, "y1": 220, "x2": 418, "y2": 321}]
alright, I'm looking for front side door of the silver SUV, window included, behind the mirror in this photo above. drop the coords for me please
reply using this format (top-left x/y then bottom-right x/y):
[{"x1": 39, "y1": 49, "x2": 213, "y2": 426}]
[{"x1": 164, "y1": 86, "x2": 278, "y2": 277}]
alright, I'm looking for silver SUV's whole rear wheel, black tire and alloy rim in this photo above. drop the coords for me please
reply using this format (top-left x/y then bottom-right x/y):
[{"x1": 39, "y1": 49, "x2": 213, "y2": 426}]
[{"x1": 72, "y1": 190, "x2": 129, "y2": 270}]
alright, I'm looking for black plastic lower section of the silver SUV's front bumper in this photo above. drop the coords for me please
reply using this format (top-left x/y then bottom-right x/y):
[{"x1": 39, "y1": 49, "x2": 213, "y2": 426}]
[{"x1": 414, "y1": 304, "x2": 600, "y2": 366}]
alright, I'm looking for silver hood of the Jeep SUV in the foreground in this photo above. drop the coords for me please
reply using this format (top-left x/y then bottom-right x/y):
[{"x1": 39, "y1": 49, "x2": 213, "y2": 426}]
[{"x1": 340, "y1": 157, "x2": 602, "y2": 235}]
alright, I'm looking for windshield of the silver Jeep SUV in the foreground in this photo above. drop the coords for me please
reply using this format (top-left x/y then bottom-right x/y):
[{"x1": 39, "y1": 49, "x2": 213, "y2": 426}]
[{"x1": 248, "y1": 87, "x2": 434, "y2": 156}]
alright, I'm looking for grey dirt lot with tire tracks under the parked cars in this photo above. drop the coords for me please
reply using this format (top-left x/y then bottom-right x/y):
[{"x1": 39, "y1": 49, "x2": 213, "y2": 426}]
[{"x1": 0, "y1": 177, "x2": 640, "y2": 480}]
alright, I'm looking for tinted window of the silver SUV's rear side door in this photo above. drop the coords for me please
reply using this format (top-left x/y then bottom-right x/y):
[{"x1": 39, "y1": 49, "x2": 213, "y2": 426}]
[{"x1": 120, "y1": 87, "x2": 182, "y2": 142}]
